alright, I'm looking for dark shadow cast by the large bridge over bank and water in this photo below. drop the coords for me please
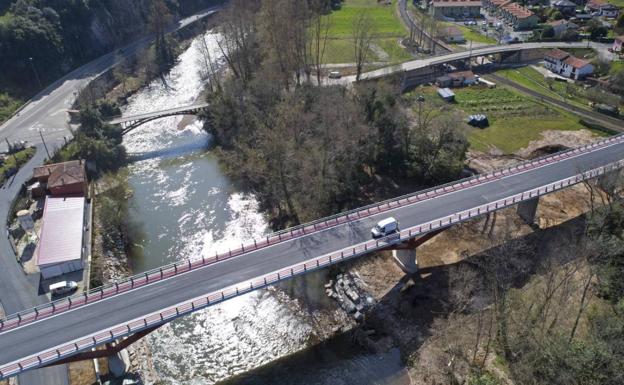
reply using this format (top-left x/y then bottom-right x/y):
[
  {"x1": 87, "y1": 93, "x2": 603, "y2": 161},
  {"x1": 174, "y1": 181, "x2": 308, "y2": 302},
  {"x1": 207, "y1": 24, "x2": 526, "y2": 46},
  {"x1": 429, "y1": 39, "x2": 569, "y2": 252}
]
[{"x1": 220, "y1": 216, "x2": 585, "y2": 385}]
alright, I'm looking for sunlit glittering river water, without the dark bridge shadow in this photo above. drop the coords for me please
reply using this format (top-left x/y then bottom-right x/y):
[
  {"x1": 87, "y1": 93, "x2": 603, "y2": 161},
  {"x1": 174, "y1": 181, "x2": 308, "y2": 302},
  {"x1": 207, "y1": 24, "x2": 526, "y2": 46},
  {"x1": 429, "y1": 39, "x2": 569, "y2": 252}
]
[{"x1": 124, "y1": 34, "x2": 324, "y2": 384}]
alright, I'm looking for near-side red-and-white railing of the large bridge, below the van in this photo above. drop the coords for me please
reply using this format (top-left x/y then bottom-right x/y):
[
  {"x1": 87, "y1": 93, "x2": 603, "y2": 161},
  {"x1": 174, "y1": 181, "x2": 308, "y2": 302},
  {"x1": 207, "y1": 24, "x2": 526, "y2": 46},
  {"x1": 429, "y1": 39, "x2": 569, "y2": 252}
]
[{"x1": 0, "y1": 155, "x2": 624, "y2": 379}]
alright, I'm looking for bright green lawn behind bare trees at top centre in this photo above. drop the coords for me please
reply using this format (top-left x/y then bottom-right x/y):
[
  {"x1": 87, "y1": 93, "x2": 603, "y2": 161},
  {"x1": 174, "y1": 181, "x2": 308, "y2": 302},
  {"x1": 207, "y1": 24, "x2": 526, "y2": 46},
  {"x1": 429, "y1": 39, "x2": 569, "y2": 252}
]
[{"x1": 324, "y1": 0, "x2": 411, "y2": 63}]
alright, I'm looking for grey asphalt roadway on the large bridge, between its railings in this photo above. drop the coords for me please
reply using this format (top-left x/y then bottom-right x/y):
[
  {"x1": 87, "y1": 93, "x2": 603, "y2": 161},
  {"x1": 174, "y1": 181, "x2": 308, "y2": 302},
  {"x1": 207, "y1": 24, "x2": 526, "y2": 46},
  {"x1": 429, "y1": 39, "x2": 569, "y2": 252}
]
[{"x1": 0, "y1": 134, "x2": 624, "y2": 372}]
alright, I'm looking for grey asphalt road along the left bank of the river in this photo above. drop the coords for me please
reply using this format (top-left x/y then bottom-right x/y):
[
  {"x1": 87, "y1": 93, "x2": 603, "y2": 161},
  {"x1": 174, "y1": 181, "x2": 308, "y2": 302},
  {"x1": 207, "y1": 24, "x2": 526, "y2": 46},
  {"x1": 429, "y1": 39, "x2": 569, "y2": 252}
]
[{"x1": 0, "y1": 7, "x2": 218, "y2": 385}]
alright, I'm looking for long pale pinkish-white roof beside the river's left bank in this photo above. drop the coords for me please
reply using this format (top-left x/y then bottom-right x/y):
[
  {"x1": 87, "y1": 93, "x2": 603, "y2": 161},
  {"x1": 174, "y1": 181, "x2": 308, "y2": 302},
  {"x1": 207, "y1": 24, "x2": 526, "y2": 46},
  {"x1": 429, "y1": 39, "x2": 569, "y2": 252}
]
[{"x1": 37, "y1": 197, "x2": 85, "y2": 266}]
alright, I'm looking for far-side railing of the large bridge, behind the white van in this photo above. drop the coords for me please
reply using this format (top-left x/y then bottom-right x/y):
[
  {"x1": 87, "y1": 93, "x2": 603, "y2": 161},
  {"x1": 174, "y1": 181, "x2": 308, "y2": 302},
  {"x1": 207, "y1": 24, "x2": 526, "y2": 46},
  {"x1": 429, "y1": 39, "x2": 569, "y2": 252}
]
[{"x1": 0, "y1": 134, "x2": 624, "y2": 333}]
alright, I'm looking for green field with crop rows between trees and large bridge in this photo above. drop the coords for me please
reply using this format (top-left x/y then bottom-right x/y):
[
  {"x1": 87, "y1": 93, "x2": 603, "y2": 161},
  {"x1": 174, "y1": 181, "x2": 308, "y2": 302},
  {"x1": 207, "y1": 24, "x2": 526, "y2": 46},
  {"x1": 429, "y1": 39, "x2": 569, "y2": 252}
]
[{"x1": 414, "y1": 86, "x2": 596, "y2": 154}]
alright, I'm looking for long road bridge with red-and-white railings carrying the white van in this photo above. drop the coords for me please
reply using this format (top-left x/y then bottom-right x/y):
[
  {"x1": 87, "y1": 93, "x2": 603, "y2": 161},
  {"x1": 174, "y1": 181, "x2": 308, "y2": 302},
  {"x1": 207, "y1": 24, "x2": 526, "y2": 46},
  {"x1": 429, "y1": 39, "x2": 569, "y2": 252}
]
[{"x1": 0, "y1": 135, "x2": 624, "y2": 379}]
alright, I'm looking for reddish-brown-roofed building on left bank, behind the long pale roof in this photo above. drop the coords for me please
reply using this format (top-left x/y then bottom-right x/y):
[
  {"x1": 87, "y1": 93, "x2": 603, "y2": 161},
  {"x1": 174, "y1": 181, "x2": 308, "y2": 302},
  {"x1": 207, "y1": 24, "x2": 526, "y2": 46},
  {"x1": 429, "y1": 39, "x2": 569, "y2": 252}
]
[{"x1": 33, "y1": 160, "x2": 87, "y2": 196}]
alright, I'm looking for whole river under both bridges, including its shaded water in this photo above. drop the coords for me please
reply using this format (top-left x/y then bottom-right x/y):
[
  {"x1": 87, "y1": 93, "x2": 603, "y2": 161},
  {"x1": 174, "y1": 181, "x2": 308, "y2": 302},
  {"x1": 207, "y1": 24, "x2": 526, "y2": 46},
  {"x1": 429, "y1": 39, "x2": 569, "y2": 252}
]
[{"x1": 123, "y1": 33, "x2": 410, "y2": 384}]
